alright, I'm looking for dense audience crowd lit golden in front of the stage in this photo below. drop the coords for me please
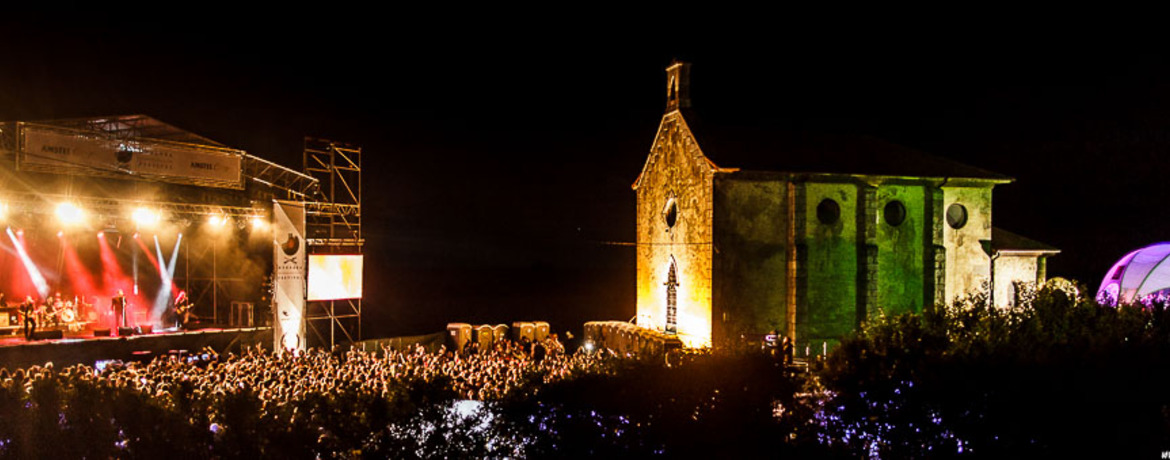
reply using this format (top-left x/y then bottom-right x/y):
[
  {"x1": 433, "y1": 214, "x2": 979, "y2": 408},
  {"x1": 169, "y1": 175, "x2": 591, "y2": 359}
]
[{"x1": 0, "y1": 335, "x2": 600, "y2": 404}]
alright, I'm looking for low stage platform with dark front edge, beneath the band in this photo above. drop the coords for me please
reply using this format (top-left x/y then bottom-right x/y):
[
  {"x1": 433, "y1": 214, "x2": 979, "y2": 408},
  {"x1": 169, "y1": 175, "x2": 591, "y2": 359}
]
[{"x1": 0, "y1": 328, "x2": 273, "y2": 369}]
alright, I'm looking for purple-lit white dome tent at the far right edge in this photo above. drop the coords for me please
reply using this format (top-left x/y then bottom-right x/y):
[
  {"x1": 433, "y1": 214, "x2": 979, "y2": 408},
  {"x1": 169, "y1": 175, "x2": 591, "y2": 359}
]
[{"x1": 1097, "y1": 242, "x2": 1170, "y2": 305}]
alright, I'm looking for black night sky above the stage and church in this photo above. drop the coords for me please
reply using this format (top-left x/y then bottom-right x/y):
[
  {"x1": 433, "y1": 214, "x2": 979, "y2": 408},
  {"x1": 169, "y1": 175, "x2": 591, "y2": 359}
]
[{"x1": 0, "y1": 14, "x2": 1170, "y2": 337}]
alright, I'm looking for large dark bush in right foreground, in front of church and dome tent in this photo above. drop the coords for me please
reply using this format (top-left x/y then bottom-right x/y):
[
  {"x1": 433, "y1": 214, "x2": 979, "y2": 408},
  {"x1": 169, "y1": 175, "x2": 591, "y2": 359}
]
[{"x1": 821, "y1": 283, "x2": 1170, "y2": 458}]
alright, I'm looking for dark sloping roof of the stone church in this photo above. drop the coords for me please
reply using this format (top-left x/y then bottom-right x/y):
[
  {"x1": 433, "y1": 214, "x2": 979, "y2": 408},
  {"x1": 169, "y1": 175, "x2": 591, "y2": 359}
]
[{"x1": 682, "y1": 109, "x2": 1012, "y2": 183}]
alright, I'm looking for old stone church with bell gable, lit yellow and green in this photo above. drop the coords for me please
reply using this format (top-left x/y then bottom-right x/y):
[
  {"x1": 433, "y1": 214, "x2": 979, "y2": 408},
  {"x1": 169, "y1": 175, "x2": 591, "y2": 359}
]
[{"x1": 633, "y1": 62, "x2": 1059, "y2": 350}]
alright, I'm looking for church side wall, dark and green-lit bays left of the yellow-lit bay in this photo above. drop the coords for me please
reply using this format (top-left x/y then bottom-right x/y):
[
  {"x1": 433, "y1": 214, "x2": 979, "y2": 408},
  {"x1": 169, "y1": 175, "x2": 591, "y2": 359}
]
[{"x1": 711, "y1": 173, "x2": 945, "y2": 349}]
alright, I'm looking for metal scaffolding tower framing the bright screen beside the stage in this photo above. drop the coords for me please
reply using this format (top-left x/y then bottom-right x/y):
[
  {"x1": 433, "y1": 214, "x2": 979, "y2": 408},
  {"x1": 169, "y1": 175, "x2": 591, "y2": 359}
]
[{"x1": 303, "y1": 137, "x2": 365, "y2": 348}]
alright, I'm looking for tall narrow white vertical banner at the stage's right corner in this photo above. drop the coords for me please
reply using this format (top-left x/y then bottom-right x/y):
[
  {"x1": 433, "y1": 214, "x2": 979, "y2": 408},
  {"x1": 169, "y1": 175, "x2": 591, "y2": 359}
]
[{"x1": 273, "y1": 200, "x2": 307, "y2": 351}]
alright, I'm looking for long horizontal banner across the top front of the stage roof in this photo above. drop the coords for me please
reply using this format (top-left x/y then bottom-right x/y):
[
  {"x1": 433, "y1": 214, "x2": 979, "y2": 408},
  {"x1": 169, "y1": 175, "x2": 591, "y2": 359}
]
[{"x1": 19, "y1": 125, "x2": 243, "y2": 190}]
